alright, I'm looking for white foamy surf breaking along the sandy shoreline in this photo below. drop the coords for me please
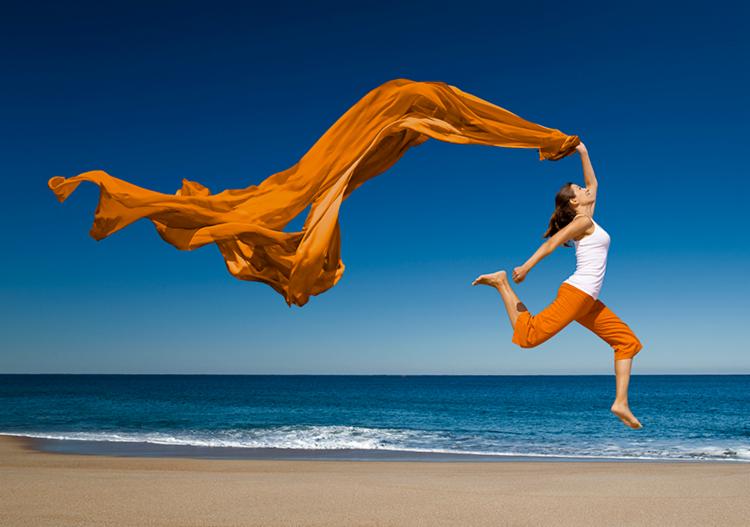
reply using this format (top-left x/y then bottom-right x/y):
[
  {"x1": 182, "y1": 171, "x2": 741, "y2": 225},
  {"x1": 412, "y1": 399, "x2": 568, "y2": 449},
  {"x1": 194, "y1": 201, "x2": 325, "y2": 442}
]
[{"x1": 0, "y1": 432, "x2": 750, "y2": 462}]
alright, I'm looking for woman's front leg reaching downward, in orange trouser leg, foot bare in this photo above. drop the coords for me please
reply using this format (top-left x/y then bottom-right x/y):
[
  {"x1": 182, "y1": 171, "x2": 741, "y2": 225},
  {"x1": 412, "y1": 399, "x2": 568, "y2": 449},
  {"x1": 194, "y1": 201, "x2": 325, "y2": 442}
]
[{"x1": 577, "y1": 300, "x2": 643, "y2": 429}]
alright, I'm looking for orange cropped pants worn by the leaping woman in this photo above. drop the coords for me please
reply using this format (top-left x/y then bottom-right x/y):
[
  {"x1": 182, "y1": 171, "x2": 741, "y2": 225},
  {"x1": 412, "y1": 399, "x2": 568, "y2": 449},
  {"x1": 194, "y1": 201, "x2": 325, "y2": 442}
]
[{"x1": 513, "y1": 282, "x2": 643, "y2": 360}]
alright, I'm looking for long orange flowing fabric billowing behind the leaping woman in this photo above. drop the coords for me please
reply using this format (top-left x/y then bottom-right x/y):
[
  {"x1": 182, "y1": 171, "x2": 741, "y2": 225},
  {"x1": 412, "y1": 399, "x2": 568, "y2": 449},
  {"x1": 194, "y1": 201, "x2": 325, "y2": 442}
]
[{"x1": 48, "y1": 79, "x2": 580, "y2": 307}]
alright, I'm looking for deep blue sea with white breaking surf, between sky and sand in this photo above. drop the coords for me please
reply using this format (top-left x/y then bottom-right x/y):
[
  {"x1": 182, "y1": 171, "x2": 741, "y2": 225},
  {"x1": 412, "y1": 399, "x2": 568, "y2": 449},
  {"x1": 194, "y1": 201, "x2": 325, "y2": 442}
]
[{"x1": 0, "y1": 375, "x2": 750, "y2": 462}]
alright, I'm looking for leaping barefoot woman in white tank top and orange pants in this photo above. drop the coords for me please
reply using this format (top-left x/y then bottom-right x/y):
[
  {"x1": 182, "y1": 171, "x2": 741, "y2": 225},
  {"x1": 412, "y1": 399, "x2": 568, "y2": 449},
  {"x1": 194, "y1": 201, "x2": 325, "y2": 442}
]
[{"x1": 472, "y1": 143, "x2": 643, "y2": 429}]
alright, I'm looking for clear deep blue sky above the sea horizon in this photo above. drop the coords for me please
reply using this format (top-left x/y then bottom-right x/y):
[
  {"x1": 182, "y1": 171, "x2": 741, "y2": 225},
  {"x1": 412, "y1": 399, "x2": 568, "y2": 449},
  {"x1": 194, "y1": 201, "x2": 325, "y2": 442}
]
[{"x1": 0, "y1": 1, "x2": 750, "y2": 374}]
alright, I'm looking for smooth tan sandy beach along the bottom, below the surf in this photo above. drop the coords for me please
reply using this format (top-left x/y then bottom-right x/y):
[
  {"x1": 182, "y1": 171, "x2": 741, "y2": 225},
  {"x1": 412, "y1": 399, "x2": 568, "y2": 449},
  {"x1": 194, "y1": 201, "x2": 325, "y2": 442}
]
[{"x1": 0, "y1": 436, "x2": 750, "y2": 527}]
